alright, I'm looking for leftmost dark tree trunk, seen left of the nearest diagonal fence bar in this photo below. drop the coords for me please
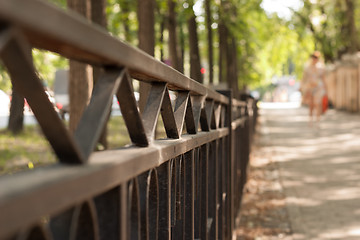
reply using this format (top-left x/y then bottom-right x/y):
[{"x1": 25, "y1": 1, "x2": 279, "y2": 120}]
[{"x1": 8, "y1": 87, "x2": 24, "y2": 134}]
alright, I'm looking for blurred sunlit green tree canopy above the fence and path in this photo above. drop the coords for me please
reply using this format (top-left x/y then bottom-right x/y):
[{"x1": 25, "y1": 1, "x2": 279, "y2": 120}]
[{"x1": 0, "y1": 0, "x2": 360, "y2": 91}]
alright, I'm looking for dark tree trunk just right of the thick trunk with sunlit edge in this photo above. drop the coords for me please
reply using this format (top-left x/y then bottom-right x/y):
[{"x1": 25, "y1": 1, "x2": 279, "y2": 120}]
[{"x1": 91, "y1": 0, "x2": 110, "y2": 149}]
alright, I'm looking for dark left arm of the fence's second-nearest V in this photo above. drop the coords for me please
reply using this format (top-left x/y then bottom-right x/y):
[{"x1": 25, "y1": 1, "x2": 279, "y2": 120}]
[{"x1": 116, "y1": 71, "x2": 149, "y2": 147}]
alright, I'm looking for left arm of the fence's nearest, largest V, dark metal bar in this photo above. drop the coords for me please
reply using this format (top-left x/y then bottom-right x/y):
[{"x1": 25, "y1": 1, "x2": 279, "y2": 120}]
[{"x1": 0, "y1": 28, "x2": 86, "y2": 163}]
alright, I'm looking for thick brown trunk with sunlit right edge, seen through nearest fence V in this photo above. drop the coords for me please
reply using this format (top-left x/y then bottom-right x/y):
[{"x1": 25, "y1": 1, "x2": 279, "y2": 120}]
[{"x1": 68, "y1": 0, "x2": 93, "y2": 132}]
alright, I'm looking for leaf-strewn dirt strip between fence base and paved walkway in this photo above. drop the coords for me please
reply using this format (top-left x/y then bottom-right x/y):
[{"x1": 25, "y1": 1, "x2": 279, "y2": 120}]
[{"x1": 237, "y1": 134, "x2": 291, "y2": 240}]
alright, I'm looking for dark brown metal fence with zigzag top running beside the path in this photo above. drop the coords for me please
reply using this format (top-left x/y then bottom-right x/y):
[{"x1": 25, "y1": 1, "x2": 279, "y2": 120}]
[{"x1": 0, "y1": 0, "x2": 256, "y2": 240}]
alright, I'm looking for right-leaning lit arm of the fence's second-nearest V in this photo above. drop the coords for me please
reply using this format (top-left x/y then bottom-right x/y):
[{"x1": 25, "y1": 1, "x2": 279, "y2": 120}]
[{"x1": 142, "y1": 82, "x2": 166, "y2": 142}]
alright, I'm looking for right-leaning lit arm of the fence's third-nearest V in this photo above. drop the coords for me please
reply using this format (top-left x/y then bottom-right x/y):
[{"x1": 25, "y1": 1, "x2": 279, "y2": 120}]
[{"x1": 174, "y1": 91, "x2": 190, "y2": 135}]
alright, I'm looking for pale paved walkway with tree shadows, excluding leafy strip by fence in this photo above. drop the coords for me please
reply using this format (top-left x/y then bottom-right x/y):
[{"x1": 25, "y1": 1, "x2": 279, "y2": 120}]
[{"x1": 259, "y1": 106, "x2": 360, "y2": 240}]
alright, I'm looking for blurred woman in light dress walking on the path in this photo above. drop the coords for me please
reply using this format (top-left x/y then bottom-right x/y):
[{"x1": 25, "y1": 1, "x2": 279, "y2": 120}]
[{"x1": 301, "y1": 51, "x2": 326, "y2": 126}]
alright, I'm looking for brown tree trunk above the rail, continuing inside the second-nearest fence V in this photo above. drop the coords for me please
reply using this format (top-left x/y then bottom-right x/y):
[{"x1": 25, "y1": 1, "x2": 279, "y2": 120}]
[{"x1": 137, "y1": 0, "x2": 155, "y2": 112}]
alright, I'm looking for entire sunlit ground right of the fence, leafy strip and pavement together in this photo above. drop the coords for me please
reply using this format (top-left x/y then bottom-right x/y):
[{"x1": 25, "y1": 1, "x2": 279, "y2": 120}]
[{"x1": 237, "y1": 106, "x2": 360, "y2": 240}]
